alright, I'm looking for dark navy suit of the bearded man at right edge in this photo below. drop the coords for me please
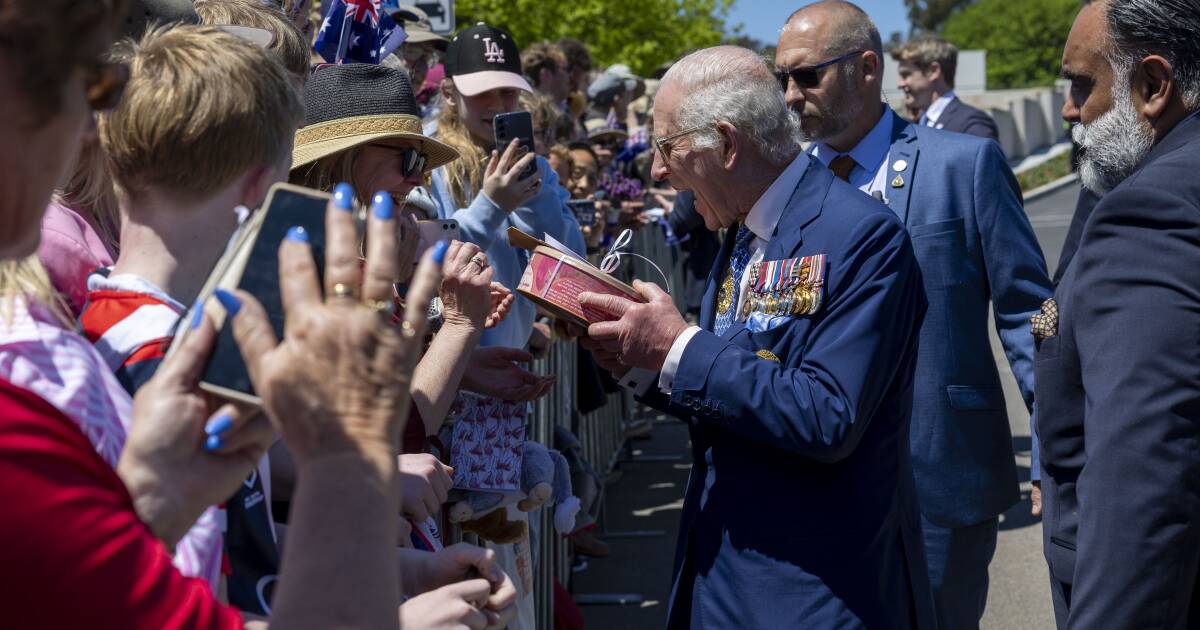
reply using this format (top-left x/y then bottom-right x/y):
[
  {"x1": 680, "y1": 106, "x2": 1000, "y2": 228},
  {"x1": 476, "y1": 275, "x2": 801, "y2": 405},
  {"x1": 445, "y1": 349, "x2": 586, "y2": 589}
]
[{"x1": 1037, "y1": 114, "x2": 1200, "y2": 630}]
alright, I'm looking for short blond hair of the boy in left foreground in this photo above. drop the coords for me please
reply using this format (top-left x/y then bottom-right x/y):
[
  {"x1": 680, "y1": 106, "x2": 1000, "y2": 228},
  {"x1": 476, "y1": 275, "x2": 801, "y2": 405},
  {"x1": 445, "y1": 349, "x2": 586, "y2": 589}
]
[{"x1": 100, "y1": 26, "x2": 304, "y2": 198}]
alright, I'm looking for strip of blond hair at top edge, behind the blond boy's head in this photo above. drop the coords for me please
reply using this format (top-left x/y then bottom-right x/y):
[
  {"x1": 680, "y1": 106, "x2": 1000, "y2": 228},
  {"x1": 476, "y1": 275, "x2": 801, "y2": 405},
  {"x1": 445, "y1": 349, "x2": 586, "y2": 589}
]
[{"x1": 193, "y1": 0, "x2": 312, "y2": 85}]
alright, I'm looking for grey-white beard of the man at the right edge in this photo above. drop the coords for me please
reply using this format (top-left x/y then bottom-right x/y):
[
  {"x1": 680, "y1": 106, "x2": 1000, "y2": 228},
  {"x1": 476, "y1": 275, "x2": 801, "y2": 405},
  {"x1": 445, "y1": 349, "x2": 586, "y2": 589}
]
[{"x1": 1072, "y1": 82, "x2": 1154, "y2": 194}]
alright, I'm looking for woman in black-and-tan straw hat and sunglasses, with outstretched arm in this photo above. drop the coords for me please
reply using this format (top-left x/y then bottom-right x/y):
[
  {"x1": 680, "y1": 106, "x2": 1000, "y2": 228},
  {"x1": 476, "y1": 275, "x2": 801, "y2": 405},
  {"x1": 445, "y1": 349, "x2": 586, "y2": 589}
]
[{"x1": 290, "y1": 64, "x2": 552, "y2": 511}]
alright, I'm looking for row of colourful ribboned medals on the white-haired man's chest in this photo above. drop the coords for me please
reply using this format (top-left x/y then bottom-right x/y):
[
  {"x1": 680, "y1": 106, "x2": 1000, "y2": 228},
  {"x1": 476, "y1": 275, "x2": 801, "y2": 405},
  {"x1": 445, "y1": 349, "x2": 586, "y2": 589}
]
[{"x1": 742, "y1": 253, "x2": 826, "y2": 319}]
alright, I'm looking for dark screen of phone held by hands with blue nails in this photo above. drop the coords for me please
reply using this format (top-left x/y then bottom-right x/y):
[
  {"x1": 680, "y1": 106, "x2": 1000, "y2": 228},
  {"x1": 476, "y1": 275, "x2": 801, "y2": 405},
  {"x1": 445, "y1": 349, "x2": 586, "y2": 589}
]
[{"x1": 203, "y1": 188, "x2": 328, "y2": 395}]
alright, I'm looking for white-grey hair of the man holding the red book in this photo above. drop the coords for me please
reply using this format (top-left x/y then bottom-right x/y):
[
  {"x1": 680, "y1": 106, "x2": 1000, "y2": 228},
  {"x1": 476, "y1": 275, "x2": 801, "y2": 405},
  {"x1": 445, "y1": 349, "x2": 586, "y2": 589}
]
[{"x1": 659, "y1": 46, "x2": 803, "y2": 166}]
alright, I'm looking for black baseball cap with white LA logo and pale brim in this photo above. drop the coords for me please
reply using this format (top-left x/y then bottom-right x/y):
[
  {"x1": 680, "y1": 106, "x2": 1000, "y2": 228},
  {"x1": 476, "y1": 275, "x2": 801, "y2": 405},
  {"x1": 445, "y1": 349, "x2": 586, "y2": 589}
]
[{"x1": 445, "y1": 22, "x2": 533, "y2": 96}]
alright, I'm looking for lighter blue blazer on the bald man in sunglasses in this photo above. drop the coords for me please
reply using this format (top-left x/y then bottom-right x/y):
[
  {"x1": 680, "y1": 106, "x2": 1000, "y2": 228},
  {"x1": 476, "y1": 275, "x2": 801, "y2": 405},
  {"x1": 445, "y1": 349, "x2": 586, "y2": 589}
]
[{"x1": 887, "y1": 114, "x2": 1052, "y2": 527}]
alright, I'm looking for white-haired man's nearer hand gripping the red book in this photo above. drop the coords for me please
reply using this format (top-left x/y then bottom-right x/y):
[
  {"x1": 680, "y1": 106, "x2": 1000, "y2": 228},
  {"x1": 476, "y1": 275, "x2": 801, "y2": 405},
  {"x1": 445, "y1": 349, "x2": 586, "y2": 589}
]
[{"x1": 580, "y1": 280, "x2": 688, "y2": 374}]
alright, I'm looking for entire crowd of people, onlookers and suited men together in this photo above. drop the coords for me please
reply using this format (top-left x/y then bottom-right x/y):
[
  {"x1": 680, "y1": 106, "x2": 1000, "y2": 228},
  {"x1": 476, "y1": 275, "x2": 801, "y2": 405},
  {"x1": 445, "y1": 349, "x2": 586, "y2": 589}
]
[{"x1": 0, "y1": 0, "x2": 1200, "y2": 630}]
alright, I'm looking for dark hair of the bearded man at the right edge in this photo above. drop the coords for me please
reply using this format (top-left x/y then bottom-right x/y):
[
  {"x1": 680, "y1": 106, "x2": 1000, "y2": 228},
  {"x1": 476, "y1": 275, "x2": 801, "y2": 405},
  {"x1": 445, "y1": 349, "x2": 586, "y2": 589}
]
[{"x1": 1085, "y1": 0, "x2": 1200, "y2": 109}]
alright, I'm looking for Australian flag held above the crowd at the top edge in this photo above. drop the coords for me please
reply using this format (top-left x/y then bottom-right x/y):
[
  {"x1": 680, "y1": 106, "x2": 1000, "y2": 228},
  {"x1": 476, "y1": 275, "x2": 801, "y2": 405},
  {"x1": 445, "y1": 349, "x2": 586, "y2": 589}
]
[{"x1": 313, "y1": 0, "x2": 407, "y2": 64}]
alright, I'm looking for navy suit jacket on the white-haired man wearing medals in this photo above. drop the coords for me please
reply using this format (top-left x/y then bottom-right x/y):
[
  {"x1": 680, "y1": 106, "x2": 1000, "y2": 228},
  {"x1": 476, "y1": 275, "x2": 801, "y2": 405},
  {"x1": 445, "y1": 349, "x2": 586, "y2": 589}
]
[{"x1": 643, "y1": 156, "x2": 935, "y2": 630}]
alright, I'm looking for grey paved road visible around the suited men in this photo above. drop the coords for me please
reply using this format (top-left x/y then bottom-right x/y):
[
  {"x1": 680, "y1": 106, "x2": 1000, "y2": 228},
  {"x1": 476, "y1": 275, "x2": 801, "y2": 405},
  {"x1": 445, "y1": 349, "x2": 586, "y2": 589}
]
[{"x1": 572, "y1": 176, "x2": 1079, "y2": 630}]
